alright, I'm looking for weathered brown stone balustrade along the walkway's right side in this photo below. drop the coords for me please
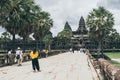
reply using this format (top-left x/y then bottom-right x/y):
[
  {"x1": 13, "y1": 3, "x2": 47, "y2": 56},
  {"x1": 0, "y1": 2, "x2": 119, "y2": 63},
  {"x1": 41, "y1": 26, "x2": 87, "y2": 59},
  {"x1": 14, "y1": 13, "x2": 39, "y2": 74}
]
[{"x1": 88, "y1": 53, "x2": 120, "y2": 80}]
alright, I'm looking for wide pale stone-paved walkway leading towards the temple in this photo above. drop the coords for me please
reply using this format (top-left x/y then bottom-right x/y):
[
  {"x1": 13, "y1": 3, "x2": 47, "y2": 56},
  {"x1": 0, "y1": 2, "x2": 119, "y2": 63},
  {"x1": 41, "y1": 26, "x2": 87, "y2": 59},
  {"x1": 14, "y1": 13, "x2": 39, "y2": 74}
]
[{"x1": 0, "y1": 51, "x2": 98, "y2": 80}]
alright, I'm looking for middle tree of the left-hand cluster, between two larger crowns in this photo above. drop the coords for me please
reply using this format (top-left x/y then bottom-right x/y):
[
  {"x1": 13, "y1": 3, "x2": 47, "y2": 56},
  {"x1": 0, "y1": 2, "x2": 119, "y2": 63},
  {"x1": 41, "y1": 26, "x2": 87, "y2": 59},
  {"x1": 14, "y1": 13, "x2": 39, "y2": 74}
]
[{"x1": 18, "y1": 4, "x2": 41, "y2": 42}]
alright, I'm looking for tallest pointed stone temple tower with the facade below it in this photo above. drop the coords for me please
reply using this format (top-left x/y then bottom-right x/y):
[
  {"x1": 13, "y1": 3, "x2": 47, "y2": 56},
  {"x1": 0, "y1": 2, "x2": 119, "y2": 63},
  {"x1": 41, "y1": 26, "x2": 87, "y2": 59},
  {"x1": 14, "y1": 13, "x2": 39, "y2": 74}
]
[{"x1": 71, "y1": 16, "x2": 88, "y2": 48}]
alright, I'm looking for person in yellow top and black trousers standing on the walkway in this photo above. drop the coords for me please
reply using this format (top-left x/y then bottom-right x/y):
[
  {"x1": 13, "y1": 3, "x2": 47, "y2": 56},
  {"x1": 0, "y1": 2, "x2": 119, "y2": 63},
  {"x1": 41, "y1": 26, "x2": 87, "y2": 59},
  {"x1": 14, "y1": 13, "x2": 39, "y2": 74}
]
[{"x1": 30, "y1": 48, "x2": 40, "y2": 72}]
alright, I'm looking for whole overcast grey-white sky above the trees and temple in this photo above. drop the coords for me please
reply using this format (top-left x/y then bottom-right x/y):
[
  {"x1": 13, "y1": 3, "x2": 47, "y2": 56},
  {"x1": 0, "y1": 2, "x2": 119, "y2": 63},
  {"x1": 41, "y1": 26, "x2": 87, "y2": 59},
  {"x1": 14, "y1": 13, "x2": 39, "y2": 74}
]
[{"x1": 0, "y1": 0, "x2": 120, "y2": 36}]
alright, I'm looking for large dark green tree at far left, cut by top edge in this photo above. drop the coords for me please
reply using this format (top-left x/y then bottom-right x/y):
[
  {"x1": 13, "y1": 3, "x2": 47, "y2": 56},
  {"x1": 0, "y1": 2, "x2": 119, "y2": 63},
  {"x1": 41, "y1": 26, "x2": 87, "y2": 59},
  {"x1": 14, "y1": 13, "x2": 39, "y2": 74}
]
[{"x1": 0, "y1": 0, "x2": 37, "y2": 49}]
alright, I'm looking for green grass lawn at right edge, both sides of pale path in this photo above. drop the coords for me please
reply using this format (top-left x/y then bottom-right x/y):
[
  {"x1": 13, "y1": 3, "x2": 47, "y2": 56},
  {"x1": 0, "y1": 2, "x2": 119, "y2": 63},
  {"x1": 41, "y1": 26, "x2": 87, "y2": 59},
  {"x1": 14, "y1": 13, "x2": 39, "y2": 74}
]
[{"x1": 104, "y1": 52, "x2": 120, "y2": 67}]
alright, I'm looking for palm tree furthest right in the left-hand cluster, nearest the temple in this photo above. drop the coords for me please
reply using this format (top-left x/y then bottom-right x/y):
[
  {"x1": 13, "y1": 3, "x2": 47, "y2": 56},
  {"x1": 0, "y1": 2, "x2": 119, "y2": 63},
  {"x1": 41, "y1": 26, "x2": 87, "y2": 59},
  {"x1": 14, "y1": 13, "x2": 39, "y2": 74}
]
[{"x1": 33, "y1": 11, "x2": 53, "y2": 47}]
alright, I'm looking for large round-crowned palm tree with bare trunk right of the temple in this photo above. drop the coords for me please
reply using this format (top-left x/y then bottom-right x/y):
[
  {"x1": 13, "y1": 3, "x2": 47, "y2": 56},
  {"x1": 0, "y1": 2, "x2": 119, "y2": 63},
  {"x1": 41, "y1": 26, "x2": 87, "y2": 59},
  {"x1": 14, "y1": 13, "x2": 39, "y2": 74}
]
[{"x1": 86, "y1": 7, "x2": 114, "y2": 53}]
